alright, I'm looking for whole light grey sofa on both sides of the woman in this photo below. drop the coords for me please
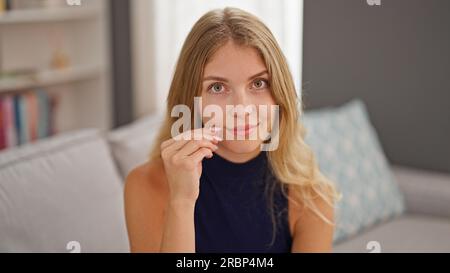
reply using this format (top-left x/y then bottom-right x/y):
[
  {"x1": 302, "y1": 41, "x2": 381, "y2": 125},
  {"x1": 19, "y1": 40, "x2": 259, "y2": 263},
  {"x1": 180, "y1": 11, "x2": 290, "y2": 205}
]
[{"x1": 0, "y1": 112, "x2": 450, "y2": 252}]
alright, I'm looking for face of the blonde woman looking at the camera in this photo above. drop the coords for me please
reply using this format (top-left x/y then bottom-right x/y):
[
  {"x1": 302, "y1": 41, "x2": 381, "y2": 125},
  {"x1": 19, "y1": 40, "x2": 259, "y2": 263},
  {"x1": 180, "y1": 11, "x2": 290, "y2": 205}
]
[{"x1": 202, "y1": 41, "x2": 275, "y2": 157}]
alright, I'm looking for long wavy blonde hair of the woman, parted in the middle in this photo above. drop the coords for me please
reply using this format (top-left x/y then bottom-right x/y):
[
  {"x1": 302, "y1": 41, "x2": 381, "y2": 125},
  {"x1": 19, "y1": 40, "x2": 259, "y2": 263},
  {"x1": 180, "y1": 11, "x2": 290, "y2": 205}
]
[{"x1": 150, "y1": 5, "x2": 338, "y2": 240}]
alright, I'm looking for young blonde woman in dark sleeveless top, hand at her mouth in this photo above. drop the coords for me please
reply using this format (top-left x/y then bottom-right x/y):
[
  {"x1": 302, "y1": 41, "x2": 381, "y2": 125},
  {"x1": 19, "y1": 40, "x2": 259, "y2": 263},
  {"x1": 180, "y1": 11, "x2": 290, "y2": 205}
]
[{"x1": 125, "y1": 8, "x2": 337, "y2": 253}]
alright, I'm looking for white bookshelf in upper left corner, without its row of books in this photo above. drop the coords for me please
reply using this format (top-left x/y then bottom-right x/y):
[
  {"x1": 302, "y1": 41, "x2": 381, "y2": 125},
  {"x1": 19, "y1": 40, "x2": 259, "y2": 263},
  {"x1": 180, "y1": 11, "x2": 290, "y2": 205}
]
[{"x1": 0, "y1": 0, "x2": 112, "y2": 132}]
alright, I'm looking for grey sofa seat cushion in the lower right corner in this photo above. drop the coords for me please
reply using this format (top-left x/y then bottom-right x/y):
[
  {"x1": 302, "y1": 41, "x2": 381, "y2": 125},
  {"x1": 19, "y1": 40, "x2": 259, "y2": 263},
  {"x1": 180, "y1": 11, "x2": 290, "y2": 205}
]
[{"x1": 333, "y1": 214, "x2": 450, "y2": 252}]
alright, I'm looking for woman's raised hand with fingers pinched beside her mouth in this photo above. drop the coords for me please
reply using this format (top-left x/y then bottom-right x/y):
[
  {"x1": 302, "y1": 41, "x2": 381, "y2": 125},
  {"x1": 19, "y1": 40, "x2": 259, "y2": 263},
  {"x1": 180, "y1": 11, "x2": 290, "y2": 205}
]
[{"x1": 161, "y1": 128, "x2": 222, "y2": 204}]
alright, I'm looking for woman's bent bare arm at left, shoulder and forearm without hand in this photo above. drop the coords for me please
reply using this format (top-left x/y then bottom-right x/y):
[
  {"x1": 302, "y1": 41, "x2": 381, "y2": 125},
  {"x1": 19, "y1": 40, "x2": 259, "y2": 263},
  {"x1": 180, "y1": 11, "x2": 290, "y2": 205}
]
[{"x1": 125, "y1": 164, "x2": 199, "y2": 252}]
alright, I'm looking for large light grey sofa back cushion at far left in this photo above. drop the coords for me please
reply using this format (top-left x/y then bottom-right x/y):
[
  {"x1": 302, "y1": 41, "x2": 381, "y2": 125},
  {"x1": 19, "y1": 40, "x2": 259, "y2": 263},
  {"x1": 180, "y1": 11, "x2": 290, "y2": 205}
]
[{"x1": 0, "y1": 130, "x2": 129, "y2": 252}]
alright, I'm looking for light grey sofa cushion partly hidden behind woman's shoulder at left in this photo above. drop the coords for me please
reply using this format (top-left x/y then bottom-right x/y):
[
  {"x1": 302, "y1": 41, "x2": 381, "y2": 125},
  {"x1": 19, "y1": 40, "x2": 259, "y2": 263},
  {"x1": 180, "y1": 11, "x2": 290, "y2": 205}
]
[{"x1": 108, "y1": 115, "x2": 163, "y2": 178}]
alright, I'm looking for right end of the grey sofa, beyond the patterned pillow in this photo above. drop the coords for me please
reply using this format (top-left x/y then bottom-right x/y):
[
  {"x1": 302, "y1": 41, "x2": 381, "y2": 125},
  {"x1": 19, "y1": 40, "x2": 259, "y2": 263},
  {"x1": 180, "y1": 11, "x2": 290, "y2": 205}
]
[{"x1": 334, "y1": 166, "x2": 450, "y2": 252}]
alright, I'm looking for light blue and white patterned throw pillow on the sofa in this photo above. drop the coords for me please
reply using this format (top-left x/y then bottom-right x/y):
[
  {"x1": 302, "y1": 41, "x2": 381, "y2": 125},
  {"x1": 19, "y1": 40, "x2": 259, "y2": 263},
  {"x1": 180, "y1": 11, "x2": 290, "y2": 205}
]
[{"x1": 303, "y1": 100, "x2": 404, "y2": 242}]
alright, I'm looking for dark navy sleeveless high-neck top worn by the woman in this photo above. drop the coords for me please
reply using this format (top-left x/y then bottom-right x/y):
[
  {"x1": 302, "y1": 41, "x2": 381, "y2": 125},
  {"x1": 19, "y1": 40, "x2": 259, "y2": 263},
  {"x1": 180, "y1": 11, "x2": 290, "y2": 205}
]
[{"x1": 194, "y1": 152, "x2": 292, "y2": 253}]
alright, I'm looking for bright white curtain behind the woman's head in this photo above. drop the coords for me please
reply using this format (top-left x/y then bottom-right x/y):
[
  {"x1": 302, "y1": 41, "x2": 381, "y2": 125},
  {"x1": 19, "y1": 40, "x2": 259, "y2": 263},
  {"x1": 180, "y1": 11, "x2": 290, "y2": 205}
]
[{"x1": 135, "y1": 0, "x2": 303, "y2": 115}]
